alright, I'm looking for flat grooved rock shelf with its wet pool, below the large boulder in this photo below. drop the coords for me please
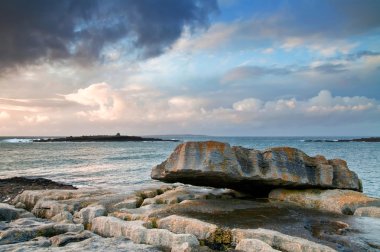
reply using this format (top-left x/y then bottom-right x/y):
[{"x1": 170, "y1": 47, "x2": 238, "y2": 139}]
[{"x1": 0, "y1": 183, "x2": 380, "y2": 252}]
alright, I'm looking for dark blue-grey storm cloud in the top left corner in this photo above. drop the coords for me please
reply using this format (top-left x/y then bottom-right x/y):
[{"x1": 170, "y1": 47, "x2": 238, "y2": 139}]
[{"x1": 0, "y1": 0, "x2": 218, "y2": 69}]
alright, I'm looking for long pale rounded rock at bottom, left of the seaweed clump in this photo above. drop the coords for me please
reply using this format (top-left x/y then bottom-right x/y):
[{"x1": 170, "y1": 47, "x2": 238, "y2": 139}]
[{"x1": 91, "y1": 216, "x2": 199, "y2": 248}]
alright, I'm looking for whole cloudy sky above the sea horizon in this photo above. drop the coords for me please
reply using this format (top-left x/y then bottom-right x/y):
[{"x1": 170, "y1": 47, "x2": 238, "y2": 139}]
[{"x1": 0, "y1": 0, "x2": 380, "y2": 136}]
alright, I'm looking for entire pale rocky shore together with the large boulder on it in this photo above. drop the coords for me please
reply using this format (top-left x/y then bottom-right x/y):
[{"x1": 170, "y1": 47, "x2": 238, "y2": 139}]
[{"x1": 0, "y1": 142, "x2": 380, "y2": 252}]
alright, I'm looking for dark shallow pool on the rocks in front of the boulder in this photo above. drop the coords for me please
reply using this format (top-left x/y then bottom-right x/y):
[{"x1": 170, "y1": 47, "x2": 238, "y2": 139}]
[{"x1": 179, "y1": 200, "x2": 380, "y2": 252}]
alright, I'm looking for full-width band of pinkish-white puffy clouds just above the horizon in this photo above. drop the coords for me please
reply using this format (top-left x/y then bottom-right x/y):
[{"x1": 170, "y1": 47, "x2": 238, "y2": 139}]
[{"x1": 0, "y1": 82, "x2": 380, "y2": 135}]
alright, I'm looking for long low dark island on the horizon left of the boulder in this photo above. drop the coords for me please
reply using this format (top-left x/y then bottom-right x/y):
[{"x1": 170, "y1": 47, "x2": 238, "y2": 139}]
[{"x1": 33, "y1": 133, "x2": 179, "y2": 143}]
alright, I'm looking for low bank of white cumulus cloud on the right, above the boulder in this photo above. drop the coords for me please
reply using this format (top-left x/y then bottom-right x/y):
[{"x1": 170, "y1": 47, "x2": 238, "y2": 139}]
[{"x1": 208, "y1": 90, "x2": 380, "y2": 130}]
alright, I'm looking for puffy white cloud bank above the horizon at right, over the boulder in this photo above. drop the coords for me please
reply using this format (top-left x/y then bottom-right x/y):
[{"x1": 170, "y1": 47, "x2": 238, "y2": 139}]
[{"x1": 217, "y1": 90, "x2": 380, "y2": 124}]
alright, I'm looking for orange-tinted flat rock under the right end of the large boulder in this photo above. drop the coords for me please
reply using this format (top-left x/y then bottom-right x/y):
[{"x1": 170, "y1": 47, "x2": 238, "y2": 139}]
[{"x1": 269, "y1": 189, "x2": 380, "y2": 215}]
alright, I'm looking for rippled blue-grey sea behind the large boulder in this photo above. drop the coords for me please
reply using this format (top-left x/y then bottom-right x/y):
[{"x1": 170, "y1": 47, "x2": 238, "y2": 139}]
[{"x1": 0, "y1": 136, "x2": 380, "y2": 197}]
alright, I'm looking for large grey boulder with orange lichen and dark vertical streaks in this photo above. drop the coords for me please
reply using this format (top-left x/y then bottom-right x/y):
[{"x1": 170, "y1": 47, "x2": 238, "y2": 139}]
[{"x1": 151, "y1": 141, "x2": 362, "y2": 194}]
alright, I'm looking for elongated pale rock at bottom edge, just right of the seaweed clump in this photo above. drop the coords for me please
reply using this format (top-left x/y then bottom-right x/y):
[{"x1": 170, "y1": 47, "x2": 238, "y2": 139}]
[{"x1": 232, "y1": 228, "x2": 336, "y2": 252}]
